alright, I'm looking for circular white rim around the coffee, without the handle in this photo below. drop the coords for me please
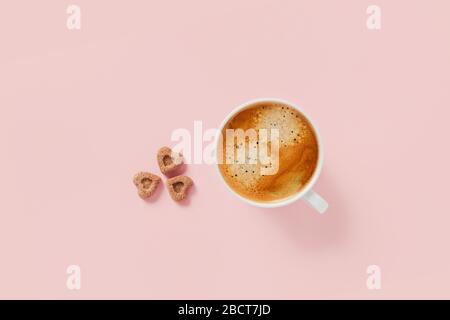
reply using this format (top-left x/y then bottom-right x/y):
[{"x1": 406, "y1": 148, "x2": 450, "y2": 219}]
[{"x1": 214, "y1": 98, "x2": 324, "y2": 208}]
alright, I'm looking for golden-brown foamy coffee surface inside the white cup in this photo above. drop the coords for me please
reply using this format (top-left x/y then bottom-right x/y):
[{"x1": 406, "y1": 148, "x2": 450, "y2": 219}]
[{"x1": 218, "y1": 102, "x2": 319, "y2": 202}]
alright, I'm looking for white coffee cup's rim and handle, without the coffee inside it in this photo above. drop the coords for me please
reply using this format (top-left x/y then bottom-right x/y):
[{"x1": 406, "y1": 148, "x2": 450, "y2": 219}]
[{"x1": 215, "y1": 98, "x2": 328, "y2": 213}]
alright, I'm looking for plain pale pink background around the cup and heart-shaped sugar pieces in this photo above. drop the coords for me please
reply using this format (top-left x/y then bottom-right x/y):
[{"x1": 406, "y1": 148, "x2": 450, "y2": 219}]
[{"x1": 0, "y1": 0, "x2": 450, "y2": 299}]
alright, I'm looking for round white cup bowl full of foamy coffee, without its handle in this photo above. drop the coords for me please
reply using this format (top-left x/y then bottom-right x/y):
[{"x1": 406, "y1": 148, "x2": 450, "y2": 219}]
[{"x1": 215, "y1": 99, "x2": 323, "y2": 207}]
